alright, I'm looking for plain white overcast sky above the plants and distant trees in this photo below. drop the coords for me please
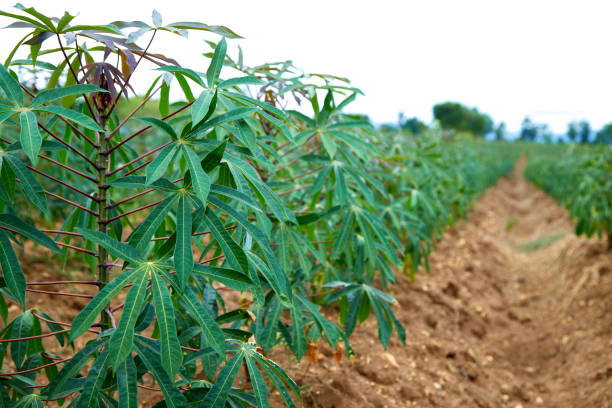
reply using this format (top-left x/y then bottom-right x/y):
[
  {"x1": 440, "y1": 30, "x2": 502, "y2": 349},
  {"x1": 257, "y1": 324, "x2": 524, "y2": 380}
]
[{"x1": 0, "y1": 0, "x2": 612, "y2": 133}]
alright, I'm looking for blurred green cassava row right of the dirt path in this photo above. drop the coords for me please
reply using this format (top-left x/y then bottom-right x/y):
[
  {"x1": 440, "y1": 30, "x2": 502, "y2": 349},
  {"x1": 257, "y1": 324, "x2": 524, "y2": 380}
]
[{"x1": 525, "y1": 144, "x2": 612, "y2": 249}]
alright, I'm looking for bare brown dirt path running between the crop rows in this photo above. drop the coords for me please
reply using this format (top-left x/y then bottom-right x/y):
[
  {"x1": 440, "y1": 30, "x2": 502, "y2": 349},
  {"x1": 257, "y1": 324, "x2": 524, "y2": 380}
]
[{"x1": 278, "y1": 163, "x2": 612, "y2": 408}]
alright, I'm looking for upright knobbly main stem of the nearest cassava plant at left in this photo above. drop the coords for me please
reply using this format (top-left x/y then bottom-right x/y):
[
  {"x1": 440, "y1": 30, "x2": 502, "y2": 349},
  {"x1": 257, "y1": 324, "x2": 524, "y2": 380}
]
[{"x1": 97, "y1": 115, "x2": 111, "y2": 331}]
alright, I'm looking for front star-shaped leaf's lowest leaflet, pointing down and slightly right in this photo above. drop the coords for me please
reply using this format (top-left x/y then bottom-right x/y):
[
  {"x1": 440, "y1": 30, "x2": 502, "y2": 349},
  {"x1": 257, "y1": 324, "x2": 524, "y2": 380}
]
[{"x1": 151, "y1": 273, "x2": 183, "y2": 378}]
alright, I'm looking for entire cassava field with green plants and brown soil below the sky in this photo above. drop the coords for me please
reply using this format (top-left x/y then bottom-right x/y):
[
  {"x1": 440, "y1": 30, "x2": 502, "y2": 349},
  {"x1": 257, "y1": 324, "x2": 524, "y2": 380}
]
[{"x1": 0, "y1": 5, "x2": 612, "y2": 408}]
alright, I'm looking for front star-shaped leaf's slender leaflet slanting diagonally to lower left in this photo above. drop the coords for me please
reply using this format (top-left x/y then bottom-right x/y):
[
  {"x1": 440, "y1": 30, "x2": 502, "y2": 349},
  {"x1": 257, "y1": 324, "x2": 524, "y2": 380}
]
[{"x1": 70, "y1": 267, "x2": 146, "y2": 342}]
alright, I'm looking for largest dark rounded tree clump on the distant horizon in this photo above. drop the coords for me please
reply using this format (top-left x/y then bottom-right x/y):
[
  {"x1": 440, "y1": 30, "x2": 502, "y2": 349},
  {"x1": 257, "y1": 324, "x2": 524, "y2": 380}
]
[{"x1": 433, "y1": 102, "x2": 493, "y2": 136}]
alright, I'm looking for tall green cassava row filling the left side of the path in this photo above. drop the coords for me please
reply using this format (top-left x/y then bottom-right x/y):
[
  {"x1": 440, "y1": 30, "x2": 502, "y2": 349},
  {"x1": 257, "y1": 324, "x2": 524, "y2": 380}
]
[{"x1": 0, "y1": 5, "x2": 514, "y2": 407}]
